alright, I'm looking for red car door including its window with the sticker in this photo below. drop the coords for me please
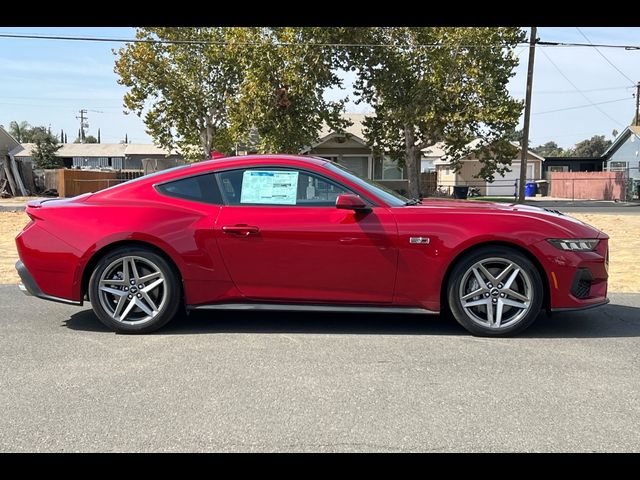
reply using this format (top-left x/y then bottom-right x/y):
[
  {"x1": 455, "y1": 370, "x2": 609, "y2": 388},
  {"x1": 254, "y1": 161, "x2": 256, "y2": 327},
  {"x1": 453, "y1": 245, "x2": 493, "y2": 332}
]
[{"x1": 215, "y1": 167, "x2": 398, "y2": 303}]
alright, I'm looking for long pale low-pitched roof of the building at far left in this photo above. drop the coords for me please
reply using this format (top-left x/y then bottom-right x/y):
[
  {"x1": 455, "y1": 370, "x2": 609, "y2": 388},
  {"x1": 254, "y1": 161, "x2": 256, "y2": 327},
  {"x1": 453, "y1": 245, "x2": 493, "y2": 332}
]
[{"x1": 10, "y1": 143, "x2": 179, "y2": 157}]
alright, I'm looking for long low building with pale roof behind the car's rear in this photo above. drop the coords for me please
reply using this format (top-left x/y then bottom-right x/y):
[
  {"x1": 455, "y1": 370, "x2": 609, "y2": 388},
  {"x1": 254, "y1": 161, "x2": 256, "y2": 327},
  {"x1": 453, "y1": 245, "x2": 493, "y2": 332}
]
[{"x1": 10, "y1": 143, "x2": 182, "y2": 170}]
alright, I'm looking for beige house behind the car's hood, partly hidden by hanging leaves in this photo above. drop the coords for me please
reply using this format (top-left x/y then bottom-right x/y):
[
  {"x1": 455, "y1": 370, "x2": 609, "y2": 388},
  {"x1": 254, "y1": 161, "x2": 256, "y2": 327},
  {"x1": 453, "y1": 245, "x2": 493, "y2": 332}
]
[{"x1": 434, "y1": 139, "x2": 544, "y2": 196}]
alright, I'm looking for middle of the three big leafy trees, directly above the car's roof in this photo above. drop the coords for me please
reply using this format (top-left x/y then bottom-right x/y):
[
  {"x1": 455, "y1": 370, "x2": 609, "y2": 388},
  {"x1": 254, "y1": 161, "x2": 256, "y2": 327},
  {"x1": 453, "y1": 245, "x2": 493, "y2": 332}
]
[{"x1": 230, "y1": 27, "x2": 347, "y2": 153}]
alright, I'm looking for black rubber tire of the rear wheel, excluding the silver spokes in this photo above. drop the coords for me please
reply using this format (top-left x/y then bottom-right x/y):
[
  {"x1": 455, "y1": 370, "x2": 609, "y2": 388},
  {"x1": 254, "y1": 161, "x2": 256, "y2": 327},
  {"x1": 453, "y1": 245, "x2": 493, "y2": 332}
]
[{"x1": 89, "y1": 246, "x2": 181, "y2": 333}]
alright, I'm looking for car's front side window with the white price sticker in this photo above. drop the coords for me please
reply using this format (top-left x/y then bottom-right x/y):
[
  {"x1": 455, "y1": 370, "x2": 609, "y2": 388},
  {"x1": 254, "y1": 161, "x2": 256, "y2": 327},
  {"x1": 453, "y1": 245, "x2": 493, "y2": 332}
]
[{"x1": 219, "y1": 168, "x2": 351, "y2": 207}]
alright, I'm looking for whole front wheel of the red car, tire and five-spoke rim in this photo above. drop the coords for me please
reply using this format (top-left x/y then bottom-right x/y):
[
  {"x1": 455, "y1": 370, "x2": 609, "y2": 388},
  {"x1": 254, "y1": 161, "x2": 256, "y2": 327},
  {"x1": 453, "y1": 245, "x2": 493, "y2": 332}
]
[{"x1": 447, "y1": 246, "x2": 544, "y2": 337}]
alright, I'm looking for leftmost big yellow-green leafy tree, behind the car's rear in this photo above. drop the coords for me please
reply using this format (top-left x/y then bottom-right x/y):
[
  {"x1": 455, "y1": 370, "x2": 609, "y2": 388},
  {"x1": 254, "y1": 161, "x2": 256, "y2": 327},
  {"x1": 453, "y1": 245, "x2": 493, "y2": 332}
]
[{"x1": 114, "y1": 27, "x2": 240, "y2": 159}]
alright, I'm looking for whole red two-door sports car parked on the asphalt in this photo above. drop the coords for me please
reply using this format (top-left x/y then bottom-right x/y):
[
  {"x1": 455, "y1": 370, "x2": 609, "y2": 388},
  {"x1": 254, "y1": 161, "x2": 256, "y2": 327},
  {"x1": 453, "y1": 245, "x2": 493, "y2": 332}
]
[{"x1": 16, "y1": 155, "x2": 608, "y2": 336}]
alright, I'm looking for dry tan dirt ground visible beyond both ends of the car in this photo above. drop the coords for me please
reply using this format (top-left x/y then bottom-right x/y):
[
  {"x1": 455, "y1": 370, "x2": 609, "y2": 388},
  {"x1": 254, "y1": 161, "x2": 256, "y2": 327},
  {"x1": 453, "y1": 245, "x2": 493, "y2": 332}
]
[{"x1": 0, "y1": 212, "x2": 640, "y2": 292}]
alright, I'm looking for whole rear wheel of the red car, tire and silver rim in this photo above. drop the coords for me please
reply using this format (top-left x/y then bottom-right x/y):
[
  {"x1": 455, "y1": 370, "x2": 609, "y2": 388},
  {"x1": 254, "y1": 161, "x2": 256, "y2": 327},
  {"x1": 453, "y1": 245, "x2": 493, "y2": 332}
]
[{"x1": 89, "y1": 246, "x2": 181, "y2": 333}]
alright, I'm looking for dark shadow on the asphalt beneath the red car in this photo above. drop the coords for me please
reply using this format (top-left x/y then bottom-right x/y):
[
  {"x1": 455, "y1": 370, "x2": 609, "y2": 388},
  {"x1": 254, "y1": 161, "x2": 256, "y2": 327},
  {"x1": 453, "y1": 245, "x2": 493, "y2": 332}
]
[{"x1": 63, "y1": 305, "x2": 640, "y2": 338}]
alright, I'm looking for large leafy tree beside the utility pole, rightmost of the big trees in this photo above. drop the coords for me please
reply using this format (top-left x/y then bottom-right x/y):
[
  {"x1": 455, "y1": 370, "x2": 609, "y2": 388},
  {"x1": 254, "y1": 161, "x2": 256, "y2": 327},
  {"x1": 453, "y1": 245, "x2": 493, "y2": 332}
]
[{"x1": 350, "y1": 27, "x2": 524, "y2": 197}]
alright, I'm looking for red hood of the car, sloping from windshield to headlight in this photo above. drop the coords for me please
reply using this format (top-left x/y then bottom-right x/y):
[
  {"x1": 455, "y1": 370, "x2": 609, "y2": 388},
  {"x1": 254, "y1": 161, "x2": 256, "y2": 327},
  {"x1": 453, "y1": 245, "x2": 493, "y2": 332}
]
[{"x1": 404, "y1": 199, "x2": 608, "y2": 238}]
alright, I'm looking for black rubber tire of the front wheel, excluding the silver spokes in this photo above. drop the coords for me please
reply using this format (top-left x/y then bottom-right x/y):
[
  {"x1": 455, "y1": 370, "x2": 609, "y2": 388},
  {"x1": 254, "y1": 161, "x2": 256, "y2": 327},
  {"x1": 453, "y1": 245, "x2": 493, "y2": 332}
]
[{"x1": 446, "y1": 246, "x2": 544, "y2": 337}]
